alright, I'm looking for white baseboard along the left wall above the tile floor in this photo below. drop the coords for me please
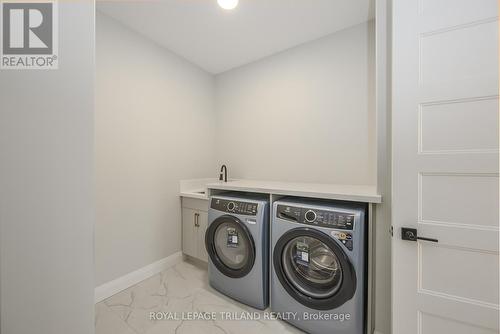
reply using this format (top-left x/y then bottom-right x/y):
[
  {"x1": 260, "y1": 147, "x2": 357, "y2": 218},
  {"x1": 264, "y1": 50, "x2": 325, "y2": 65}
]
[{"x1": 94, "y1": 252, "x2": 182, "y2": 303}]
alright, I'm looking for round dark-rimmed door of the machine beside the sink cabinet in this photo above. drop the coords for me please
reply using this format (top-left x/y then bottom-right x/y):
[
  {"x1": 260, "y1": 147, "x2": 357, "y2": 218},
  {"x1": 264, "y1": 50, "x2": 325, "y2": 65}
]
[{"x1": 205, "y1": 215, "x2": 255, "y2": 278}]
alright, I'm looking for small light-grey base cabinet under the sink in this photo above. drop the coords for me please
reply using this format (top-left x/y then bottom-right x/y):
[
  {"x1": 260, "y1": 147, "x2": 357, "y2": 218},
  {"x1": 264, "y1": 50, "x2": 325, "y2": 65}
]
[{"x1": 182, "y1": 197, "x2": 208, "y2": 262}]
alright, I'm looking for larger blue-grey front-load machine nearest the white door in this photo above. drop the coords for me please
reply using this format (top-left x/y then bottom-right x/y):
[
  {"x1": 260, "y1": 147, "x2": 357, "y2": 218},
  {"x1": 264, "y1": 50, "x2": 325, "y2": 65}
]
[{"x1": 271, "y1": 198, "x2": 367, "y2": 334}]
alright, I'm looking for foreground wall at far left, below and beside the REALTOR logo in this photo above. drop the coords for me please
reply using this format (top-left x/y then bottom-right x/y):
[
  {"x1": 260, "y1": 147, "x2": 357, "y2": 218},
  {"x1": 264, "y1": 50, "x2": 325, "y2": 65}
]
[{"x1": 0, "y1": 1, "x2": 94, "y2": 334}]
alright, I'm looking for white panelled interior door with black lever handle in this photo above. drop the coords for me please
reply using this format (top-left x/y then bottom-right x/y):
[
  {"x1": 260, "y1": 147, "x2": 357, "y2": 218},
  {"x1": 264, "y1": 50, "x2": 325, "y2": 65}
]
[{"x1": 392, "y1": 0, "x2": 499, "y2": 334}]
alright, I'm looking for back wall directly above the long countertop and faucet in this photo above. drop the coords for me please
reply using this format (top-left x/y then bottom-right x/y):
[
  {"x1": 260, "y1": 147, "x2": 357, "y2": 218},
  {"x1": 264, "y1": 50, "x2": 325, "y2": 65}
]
[{"x1": 216, "y1": 22, "x2": 376, "y2": 184}]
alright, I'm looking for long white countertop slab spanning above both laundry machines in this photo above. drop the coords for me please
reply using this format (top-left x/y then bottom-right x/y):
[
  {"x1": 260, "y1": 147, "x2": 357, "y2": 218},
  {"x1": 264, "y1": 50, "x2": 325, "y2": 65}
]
[{"x1": 206, "y1": 180, "x2": 382, "y2": 203}]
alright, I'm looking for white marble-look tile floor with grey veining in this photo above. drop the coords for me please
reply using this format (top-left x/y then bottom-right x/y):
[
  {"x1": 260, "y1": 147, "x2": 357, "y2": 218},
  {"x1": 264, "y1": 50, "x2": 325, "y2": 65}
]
[{"x1": 96, "y1": 261, "x2": 302, "y2": 334}]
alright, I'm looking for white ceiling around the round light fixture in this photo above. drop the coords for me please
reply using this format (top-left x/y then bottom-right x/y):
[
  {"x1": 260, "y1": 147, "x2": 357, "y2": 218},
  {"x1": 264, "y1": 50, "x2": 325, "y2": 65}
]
[{"x1": 97, "y1": 0, "x2": 374, "y2": 74}]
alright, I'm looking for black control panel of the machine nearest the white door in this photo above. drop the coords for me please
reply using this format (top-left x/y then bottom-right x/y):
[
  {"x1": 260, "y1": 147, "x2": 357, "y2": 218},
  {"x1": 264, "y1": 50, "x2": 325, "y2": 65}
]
[{"x1": 276, "y1": 204, "x2": 356, "y2": 230}]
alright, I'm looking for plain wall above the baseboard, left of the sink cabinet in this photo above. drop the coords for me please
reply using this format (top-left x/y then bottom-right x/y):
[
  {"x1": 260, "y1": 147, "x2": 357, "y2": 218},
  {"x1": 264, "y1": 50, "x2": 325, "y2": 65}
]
[{"x1": 95, "y1": 13, "x2": 217, "y2": 286}]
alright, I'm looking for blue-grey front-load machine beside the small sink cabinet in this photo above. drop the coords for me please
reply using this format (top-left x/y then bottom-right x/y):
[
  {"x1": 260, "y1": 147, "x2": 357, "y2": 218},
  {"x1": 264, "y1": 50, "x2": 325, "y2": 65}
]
[{"x1": 205, "y1": 193, "x2": 269, "y2": 309}]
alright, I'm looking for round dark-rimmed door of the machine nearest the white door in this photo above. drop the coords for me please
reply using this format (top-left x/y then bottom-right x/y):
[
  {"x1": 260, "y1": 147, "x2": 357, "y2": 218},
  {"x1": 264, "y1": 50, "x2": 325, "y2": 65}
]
[{"x1": 273, "y1": 228, "x2": 356, "y2": 310}]
